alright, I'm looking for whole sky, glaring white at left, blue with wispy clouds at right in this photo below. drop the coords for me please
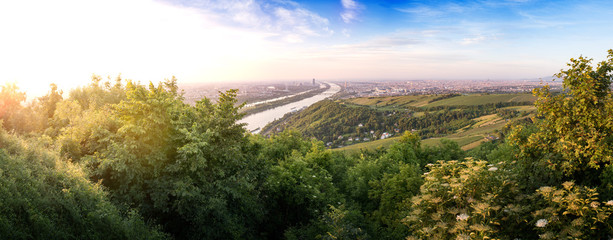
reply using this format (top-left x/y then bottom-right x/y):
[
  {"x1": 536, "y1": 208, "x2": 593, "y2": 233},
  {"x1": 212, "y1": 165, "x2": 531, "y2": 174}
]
[{"x1": 0, "y1": 0, "x2": 613, "y2": 96}]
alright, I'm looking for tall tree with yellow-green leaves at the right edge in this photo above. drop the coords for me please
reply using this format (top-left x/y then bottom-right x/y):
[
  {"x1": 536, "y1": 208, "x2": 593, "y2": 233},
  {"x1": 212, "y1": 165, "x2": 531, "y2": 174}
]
[{"x1": 515, "y1": 50, "x2": 613, "y2": 186}]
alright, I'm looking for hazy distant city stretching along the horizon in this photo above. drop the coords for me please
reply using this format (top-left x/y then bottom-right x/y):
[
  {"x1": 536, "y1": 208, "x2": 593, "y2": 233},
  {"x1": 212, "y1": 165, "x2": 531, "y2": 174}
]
[{"x1": 180, "y1": 78, "x2": 562, "y2": 104}]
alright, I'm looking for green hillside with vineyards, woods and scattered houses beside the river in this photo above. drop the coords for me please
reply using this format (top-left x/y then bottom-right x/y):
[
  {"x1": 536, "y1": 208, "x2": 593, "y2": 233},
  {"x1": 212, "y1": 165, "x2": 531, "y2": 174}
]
[{"x1": 263, "y1": 93, "x2": 535, "y2": 151}]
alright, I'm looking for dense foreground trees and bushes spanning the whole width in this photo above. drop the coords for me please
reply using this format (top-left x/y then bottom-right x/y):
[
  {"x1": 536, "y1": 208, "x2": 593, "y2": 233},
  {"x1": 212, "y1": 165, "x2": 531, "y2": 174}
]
[{"x1": 0, "y1": 51, "x2": 613, "y2": 239}]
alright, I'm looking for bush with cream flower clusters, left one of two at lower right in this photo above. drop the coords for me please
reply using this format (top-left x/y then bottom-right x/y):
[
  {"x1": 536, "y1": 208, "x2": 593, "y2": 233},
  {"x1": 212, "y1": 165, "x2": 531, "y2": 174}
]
[{"x1": 405, "y1": 158, "x2": 526, "y2": 239}]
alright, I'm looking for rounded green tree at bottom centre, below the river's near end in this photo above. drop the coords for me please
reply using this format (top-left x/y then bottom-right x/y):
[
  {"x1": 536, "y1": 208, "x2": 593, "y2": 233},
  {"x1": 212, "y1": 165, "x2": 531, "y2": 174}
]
[{"x1": 259, "y1": 131, "x2": 341, "y2": 239}]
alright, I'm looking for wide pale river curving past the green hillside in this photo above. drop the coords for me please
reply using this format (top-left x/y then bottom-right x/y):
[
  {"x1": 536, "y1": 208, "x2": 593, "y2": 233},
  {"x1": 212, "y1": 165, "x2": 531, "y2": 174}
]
[{"x1": 238, "y1": 83, "x2": 341, "y2": 133}]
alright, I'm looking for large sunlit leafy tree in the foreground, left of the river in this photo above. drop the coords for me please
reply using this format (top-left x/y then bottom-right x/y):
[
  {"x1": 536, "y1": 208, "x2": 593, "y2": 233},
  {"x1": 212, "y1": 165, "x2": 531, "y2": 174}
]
[{"x1": 88, "y1": 79, "x2": 263, "y2": 239}]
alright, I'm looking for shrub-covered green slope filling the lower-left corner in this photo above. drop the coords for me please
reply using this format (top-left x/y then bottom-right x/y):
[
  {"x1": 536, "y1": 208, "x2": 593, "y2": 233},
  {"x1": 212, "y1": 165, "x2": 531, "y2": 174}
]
[{"x1": 0, "y1": 126, "x2": 167, "y2": 239}]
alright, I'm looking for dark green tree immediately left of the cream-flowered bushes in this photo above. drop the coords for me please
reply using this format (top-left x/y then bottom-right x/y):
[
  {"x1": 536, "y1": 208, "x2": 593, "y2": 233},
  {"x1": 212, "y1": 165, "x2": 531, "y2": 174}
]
[{"x1": 342, "y1": 132, "x2": 457, "y2": 239}]
